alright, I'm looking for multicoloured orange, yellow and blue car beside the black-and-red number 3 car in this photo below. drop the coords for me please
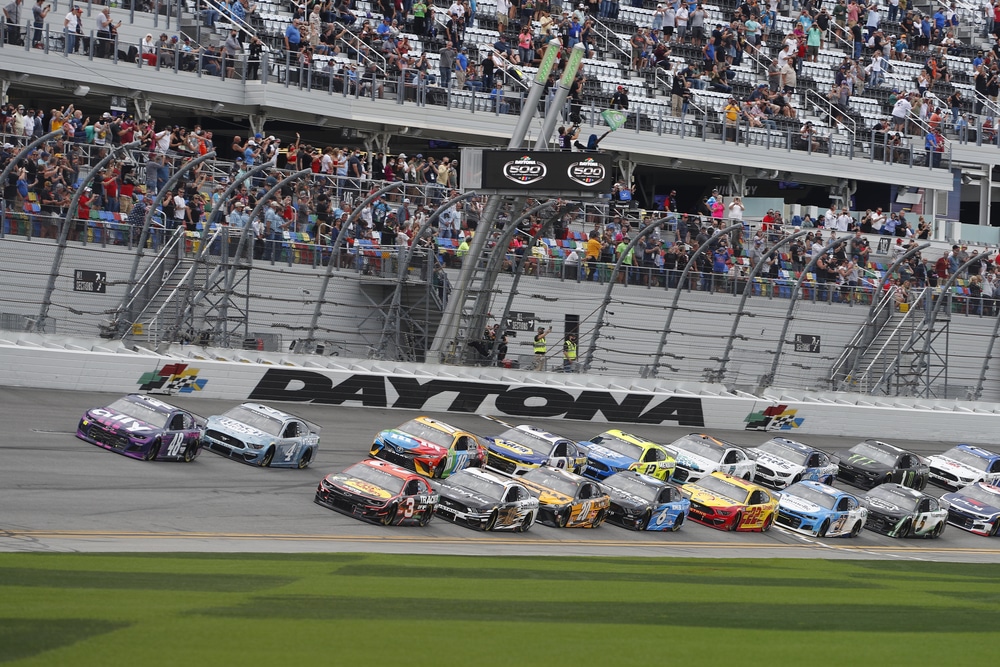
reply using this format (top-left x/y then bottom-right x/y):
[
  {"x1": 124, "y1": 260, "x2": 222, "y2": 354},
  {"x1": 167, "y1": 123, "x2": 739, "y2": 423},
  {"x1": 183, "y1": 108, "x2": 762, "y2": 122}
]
[{"x1": 371, "y1": 417, "x2": 486, "y2": 478}]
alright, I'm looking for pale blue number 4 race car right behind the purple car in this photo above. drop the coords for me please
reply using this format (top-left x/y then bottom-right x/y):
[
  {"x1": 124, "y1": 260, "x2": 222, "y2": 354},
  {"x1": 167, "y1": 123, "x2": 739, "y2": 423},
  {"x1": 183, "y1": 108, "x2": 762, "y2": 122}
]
[{"x1": 201, "y1": 403, "x2": 320, "y2": 468}]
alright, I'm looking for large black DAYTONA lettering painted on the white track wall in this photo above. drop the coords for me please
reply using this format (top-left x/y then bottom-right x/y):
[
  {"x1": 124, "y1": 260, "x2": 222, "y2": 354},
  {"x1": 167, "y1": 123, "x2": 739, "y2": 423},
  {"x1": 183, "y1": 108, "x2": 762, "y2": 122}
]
[{"x1": 248, "y1": 368, "x2": 705, "y2": 427}]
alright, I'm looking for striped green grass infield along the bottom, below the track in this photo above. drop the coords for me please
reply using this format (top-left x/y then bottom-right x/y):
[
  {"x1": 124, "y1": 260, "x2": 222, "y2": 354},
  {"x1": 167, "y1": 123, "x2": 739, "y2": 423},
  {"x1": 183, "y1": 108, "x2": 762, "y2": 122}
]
[{"x1": 0, "y1": 554, "x2": 1000, "y2": 667}]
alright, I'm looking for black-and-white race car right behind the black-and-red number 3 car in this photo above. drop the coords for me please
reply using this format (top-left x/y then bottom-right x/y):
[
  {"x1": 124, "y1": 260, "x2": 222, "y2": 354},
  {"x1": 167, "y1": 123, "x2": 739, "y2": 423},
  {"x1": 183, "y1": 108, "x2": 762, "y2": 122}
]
[{"x1": 431, "y1": 468, "x2": 538, "y2": 533}]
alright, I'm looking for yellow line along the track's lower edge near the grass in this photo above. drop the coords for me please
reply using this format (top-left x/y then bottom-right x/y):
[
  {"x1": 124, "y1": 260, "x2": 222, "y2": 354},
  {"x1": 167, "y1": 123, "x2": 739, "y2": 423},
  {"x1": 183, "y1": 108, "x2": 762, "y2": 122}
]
[{"x1": 7, "y1": 530, "x2": 1000, "y2": 555}]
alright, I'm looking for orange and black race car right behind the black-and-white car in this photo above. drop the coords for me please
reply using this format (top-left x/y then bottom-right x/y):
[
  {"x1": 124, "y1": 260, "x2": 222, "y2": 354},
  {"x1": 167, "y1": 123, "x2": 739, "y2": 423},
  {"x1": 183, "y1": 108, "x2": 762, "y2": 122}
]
[{"x1": 519, "y1": 466, "x2": 611, "y2": 528}]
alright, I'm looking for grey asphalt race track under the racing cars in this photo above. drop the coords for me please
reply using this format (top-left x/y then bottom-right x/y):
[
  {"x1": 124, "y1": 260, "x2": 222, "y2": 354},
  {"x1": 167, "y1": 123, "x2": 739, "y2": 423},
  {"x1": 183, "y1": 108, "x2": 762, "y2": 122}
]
[{"x1": 0, "y1": 388, "x2": 1000, "y2": 562}]
